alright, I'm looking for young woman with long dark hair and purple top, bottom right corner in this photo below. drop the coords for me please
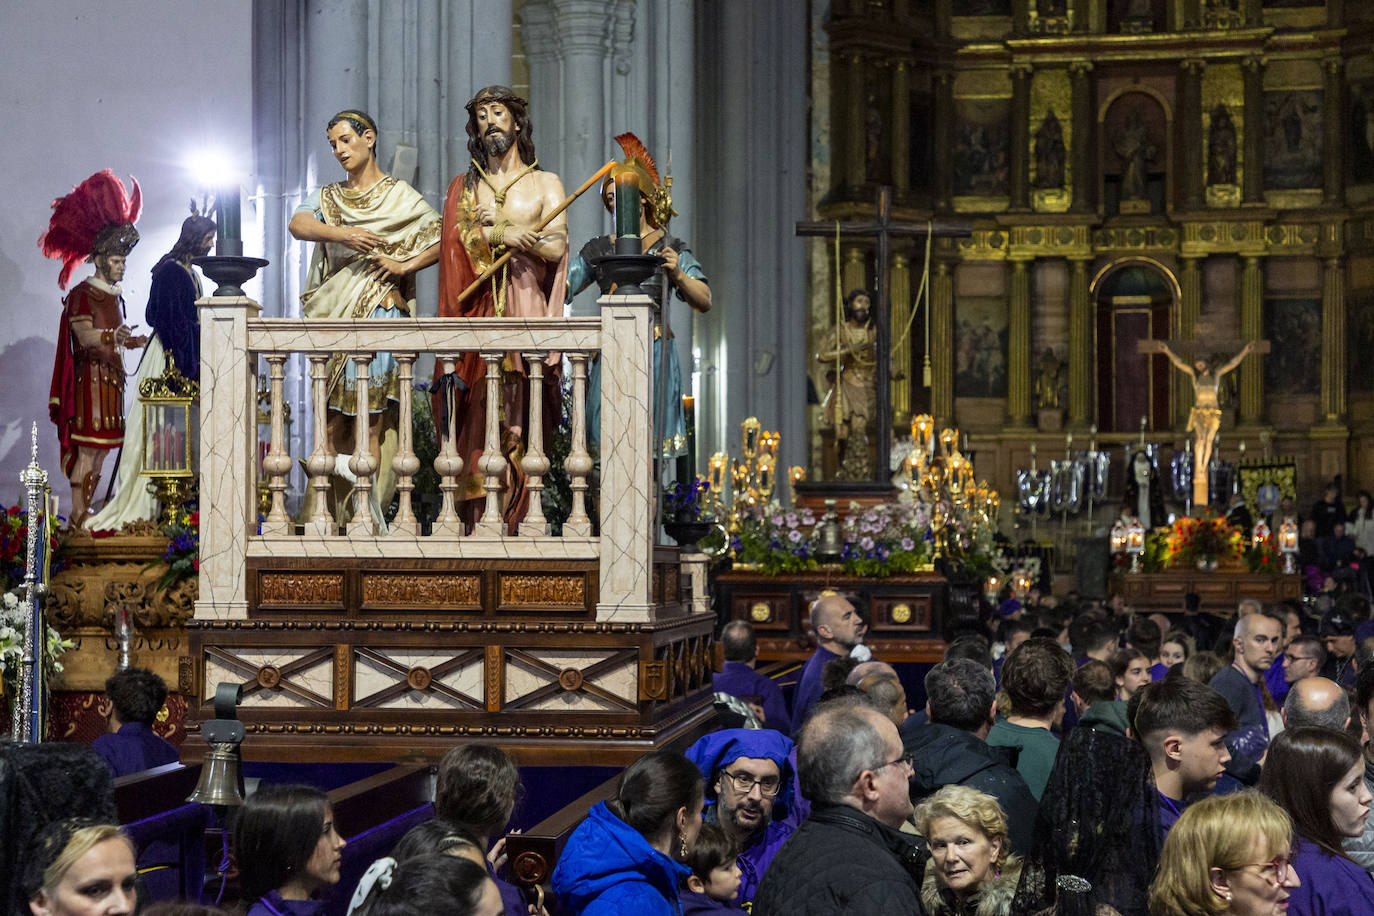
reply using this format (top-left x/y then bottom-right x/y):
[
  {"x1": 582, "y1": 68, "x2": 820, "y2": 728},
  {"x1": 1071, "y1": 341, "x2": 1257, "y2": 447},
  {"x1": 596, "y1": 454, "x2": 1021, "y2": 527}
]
[{"x1": 1256, "y1": 725, "x2": 1374, "y2": 916}]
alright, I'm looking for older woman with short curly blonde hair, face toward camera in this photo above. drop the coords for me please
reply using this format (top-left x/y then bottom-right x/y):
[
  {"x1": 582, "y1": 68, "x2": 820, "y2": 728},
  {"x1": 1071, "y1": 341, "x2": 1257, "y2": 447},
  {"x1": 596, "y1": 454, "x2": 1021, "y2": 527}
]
[{"x1": 915, "y1": 786, "x2": 1021, "y2": 916}]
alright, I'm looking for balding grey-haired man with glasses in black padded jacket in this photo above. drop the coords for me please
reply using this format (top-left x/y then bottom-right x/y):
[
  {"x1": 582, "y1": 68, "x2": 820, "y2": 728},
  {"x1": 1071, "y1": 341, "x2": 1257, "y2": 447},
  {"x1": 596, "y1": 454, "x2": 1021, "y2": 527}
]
[{"x1": 752, "y1": 703, "x2": 929, "y2": 916}]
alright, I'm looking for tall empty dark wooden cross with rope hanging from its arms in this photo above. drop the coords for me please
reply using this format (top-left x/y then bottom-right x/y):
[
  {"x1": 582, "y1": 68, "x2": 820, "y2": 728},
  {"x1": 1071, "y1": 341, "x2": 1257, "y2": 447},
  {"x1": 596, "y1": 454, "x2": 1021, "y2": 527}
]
[{"x1": 797, "y1": 185, "x2": 973, "y2": 482}]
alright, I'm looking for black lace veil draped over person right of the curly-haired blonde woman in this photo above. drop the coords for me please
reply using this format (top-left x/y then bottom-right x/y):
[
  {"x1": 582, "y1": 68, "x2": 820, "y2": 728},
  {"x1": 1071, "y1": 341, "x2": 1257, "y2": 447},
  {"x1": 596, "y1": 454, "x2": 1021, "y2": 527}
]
[{"x1": 1011, "y1": 729, "x2": 1160, "y2": 916}]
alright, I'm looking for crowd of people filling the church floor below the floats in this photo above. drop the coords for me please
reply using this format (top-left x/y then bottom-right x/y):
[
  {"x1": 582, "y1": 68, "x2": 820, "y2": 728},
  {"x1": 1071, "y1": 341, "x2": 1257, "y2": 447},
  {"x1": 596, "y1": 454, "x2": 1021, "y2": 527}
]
[{"x1": 22, "y1": 554, "x2": 1374, "y2": 916}]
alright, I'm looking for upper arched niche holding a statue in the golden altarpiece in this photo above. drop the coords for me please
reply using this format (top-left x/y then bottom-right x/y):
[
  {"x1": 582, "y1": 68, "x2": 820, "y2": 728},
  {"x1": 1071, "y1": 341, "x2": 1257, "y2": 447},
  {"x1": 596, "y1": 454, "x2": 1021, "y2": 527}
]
[{"x1": 1102, "y1": 92, "x2": 1169, "y2": 214}]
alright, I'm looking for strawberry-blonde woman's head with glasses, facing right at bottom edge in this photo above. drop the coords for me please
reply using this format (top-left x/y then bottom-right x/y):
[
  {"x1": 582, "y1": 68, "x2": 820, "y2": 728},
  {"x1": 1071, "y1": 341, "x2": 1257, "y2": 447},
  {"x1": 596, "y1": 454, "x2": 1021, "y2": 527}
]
[{"x1": 1150, "y1": 790, "x2": 1297, "y2": 916}]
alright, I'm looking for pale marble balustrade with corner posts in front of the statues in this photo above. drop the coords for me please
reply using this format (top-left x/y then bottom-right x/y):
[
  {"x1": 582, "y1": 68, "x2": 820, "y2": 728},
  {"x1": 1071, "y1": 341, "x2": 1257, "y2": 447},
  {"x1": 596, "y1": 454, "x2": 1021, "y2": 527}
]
[{"x1": 195, "y1": 295, "x2": 653, "y2": 619}]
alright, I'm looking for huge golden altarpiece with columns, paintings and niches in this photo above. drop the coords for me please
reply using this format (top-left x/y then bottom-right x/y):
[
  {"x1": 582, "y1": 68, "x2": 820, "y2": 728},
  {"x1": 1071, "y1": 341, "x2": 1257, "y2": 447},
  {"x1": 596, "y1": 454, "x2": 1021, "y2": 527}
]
[{"x1": 808, "y1": 0, "x2": 1374, "y2": 508}]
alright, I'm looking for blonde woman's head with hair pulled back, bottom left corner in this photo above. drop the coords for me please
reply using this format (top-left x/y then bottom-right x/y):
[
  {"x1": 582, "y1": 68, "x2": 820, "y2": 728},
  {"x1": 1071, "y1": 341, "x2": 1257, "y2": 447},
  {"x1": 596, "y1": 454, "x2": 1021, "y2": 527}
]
[{"x1": 22, "y1": 818, "x2": 137, "y2": 916}]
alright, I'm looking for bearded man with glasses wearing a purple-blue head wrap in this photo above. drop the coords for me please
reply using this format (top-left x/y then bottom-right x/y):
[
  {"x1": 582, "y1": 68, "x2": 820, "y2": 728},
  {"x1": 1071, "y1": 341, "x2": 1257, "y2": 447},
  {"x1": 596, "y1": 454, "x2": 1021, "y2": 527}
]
[{"x1": 687, "y1": 728, "x2": 805, "y2": 906}]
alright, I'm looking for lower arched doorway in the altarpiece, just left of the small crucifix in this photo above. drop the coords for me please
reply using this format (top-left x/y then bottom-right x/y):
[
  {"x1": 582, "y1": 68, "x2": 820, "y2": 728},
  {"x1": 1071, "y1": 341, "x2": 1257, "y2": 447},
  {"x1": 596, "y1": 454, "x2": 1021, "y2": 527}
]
[{"x1": 1088, "y1": 257, "x2": 1180, "y2": 433}]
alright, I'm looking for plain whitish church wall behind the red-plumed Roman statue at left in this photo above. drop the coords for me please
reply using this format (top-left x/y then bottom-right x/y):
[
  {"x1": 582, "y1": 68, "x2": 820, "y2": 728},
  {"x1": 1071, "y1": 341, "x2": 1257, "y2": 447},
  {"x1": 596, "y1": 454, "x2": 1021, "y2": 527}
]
[{"x1": 0, "y1": 0, "x2": 252, "y2": 497}]
